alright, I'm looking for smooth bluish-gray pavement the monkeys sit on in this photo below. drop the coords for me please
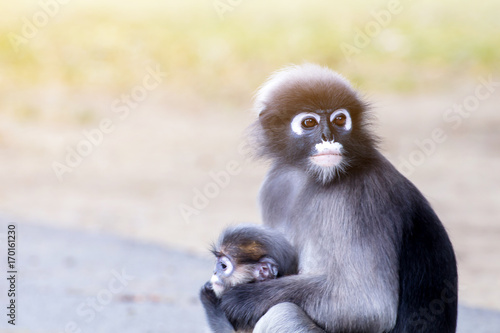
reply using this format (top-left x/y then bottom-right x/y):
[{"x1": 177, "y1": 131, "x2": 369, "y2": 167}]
[{"x1": 0, "y1": 220, "x2": 500, "y2": 333}]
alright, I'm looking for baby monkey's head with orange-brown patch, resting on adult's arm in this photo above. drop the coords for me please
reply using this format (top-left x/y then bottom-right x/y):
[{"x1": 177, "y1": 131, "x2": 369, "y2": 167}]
[{"x1": 210, "y1": 225, "x2": 298, "y2": 297}]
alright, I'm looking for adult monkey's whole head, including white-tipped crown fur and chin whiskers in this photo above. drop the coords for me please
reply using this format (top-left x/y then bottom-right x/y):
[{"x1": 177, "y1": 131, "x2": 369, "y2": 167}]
[{"x1": 255, "y1": 64, "x2": 376, "y2": 184}]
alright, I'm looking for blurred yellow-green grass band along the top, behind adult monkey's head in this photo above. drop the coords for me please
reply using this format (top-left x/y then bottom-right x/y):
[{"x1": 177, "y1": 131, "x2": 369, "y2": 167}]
[{"x1": 0, "y1": 0, "x2": 500, "y2": 101}]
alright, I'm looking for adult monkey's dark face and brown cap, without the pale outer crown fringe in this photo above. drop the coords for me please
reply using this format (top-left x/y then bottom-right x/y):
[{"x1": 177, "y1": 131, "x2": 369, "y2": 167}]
[{"x1": 259, "y1": 82, "x2": 371, "y2": 183}]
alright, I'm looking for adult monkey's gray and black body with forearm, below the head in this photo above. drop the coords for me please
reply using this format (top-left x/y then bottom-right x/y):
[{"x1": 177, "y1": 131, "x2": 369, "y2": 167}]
[{"x1": 220, "y1": 154, "x2": 457, "y2": 333}]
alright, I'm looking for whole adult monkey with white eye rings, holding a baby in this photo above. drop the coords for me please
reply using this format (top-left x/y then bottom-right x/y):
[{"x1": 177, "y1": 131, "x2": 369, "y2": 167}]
[{"x1": 207, "y1": 64, "x2": 457, "y2": 333}]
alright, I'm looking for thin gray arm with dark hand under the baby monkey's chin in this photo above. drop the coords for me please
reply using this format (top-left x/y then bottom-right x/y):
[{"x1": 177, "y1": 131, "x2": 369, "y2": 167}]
[{"x1": 200, "y1": 282, "x2": 234, "y2": 333}]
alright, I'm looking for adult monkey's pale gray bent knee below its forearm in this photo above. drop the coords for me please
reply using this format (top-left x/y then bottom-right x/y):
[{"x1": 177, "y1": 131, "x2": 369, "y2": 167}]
[{"x1": 253, "y1": 303, "x2": 325, "y2": 333}]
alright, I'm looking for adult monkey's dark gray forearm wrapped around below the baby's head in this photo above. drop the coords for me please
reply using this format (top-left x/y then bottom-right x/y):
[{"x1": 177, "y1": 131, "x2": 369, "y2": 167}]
[{"x1": 220, "y1": 275, "x2": 326, "y2": 330}]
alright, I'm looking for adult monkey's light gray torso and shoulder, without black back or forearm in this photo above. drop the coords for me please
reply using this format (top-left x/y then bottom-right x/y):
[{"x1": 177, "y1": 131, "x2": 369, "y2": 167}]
[{"x1": 260, "y1": 156, "x2": 402, "y2": 332}]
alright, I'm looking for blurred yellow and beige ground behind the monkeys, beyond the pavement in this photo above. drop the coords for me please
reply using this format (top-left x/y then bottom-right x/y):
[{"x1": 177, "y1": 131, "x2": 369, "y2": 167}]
[{"x1": 0, "y1": 0, "x2": 500, "y2": 309}]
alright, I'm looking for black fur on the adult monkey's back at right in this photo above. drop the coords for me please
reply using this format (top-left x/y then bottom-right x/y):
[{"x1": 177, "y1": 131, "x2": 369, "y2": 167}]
[{"x1": 392, "y1": 198, "x2": 457, "y2": 333}]
